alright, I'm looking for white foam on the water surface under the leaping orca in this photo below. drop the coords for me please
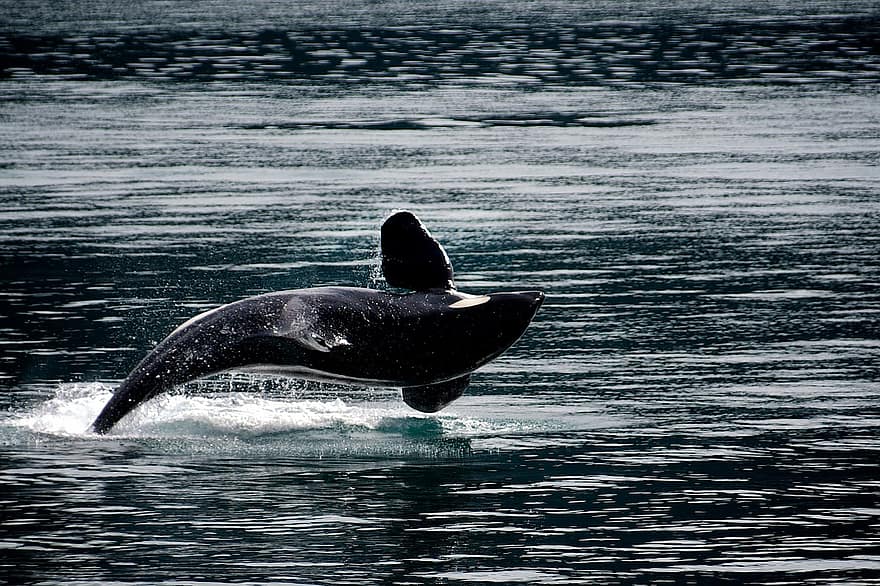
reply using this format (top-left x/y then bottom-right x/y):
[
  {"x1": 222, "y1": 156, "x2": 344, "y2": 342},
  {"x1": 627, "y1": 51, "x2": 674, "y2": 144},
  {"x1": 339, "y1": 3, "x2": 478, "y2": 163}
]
[{"x1": 3, "y1": 379, "x2": 556, "y2": 453}]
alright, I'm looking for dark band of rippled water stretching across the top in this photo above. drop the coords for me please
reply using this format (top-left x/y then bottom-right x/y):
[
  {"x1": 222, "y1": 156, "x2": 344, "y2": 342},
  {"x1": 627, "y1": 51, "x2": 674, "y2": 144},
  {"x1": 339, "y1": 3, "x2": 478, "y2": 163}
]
[{"x1": 0, "y1": 15, "x2": 880, "y2": 86}]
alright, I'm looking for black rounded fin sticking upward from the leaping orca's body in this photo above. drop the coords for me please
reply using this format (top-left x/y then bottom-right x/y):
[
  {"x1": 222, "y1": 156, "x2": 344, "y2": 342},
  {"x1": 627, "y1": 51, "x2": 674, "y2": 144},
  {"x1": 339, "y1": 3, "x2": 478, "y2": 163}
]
[{"x1": 382, "y1": 211, "x2": 455, "y2": 291}]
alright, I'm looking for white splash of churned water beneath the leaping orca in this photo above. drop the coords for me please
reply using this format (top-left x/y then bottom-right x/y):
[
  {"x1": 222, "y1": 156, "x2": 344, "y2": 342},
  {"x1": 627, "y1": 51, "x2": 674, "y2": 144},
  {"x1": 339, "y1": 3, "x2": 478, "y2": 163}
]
[{"x1": 0, "y1": 374, "x2": 556, "y2": 457}]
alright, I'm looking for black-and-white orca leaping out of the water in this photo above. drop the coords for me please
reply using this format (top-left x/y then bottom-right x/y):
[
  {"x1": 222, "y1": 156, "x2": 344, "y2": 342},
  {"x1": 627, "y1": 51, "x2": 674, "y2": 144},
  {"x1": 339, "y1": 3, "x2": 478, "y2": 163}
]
[{"x1": 91, "y1": 211, "x2": 544, "y2": 434}]
